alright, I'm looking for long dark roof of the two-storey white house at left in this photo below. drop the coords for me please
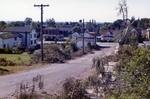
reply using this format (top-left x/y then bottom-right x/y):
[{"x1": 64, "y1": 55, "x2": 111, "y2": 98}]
[{"x1": 2, "y1": 26, "x2": 32, "y2": 33}]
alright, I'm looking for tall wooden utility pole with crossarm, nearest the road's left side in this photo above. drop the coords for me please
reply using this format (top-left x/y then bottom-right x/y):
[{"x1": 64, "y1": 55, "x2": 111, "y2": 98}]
[{"x1": 34, "y1": 4, "x2": 49, "y2": 61}]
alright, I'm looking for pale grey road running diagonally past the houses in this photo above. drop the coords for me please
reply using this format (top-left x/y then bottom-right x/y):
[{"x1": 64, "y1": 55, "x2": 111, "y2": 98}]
[{"x1": 0, "y1": 44, "x2": 117, "y2": 98}]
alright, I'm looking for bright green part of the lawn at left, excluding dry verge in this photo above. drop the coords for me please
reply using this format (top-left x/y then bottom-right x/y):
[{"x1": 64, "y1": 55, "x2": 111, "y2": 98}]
[{"x1": 0, "y1": 53, "x2": 31, "y2": 65}]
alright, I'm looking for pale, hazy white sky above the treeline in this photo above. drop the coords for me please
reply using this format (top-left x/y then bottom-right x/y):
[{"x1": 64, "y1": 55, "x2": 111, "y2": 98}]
[{"x1": 0, "y1": 0, "x2": 150, "y2": 22}]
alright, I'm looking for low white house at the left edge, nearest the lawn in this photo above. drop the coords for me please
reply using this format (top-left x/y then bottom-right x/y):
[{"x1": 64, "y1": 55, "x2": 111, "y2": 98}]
[{"x1": 0, "y1": 32, "x2": 22, "y2": 48}]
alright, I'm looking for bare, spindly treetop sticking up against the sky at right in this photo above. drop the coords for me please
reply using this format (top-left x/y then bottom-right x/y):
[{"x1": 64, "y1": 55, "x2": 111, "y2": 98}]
[{"x1": 117, "y1": 0, "x2": 128, "y2": 22}]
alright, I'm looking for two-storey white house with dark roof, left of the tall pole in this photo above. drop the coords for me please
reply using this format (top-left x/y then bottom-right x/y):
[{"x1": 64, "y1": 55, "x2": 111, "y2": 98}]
[{"x1": 1, "y1": 26, "x2": 37, "y2": 48}]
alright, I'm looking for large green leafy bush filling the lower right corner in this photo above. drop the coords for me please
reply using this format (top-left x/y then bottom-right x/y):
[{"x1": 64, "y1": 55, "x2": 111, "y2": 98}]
[{"x1": 108, "y1": 46, "x2": 150, "y2": 99}]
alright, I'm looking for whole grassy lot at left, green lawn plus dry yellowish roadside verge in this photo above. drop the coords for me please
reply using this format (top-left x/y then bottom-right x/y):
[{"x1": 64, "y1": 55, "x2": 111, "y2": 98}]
[{"x1": 0, "y1": 53, "x2": 31, "y2": 75}]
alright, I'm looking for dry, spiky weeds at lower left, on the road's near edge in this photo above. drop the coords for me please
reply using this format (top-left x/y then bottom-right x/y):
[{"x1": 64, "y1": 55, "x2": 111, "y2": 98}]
[{"x1": 15, "y1": 75, "x2": 44, "y2": 99}]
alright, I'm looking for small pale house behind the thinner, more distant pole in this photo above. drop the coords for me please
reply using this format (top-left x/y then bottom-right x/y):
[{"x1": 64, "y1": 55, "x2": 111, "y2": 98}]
[{"x1": 72, "y1": 31, "x2": 96, "y2": 48}]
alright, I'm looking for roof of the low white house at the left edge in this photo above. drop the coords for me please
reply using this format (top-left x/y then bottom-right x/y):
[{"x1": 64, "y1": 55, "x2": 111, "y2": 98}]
[{"x1": 0, "y1": 32, "x2": 22, "y2": 39}]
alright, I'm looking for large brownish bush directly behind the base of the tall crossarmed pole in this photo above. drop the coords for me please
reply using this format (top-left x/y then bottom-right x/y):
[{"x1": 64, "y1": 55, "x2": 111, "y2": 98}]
[{"x1": 32, "y1": 44, "x2": 70, "y2": 63}]
